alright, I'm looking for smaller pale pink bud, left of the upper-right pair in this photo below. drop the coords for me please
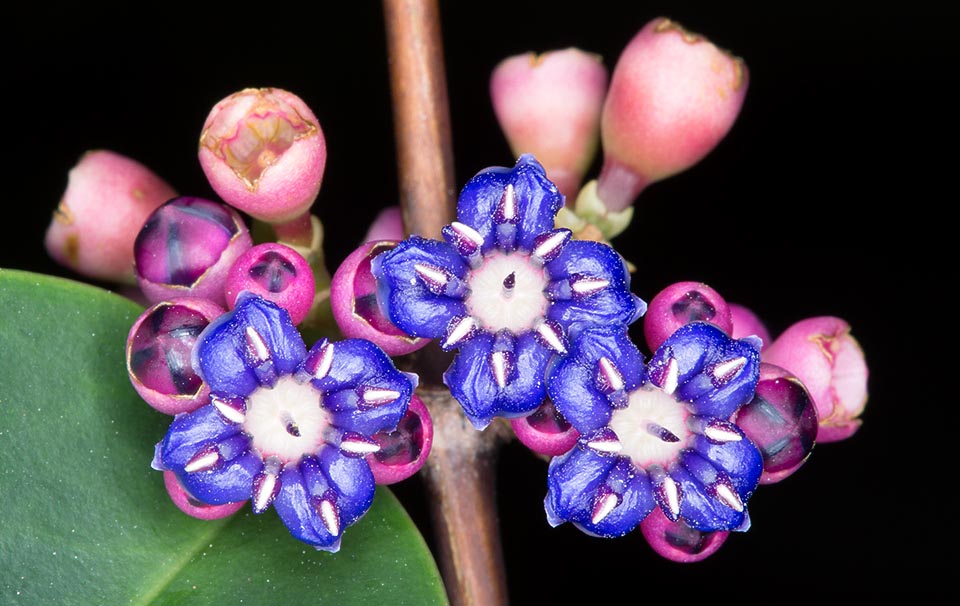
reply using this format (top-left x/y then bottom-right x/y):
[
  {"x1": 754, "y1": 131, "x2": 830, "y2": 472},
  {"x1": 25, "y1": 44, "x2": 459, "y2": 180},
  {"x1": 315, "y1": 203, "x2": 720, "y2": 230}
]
[{"x1": 490, "y1": 48, "x2": 608, "y2": 202}]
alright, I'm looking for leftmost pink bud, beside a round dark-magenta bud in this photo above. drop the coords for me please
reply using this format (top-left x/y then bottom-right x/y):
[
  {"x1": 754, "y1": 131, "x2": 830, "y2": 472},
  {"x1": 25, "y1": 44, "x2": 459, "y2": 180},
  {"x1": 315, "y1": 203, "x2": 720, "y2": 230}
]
[{"x1": 44, "y1": 150, "x2": 177, "y2": 284}]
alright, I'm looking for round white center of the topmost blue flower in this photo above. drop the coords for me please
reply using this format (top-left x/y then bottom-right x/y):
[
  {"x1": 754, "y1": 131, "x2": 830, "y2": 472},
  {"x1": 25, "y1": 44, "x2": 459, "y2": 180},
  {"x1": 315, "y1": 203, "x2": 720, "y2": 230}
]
[{"x1": 465, "y1": 251, "x2": 548, "y2": 335}]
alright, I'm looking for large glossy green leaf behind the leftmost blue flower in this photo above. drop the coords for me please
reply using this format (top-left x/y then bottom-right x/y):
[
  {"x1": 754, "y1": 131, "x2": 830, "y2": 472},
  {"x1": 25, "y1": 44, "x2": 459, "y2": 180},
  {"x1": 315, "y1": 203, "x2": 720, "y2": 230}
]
[{"x1": 0, "y1": 269, "x2": 446, "y2": 606}]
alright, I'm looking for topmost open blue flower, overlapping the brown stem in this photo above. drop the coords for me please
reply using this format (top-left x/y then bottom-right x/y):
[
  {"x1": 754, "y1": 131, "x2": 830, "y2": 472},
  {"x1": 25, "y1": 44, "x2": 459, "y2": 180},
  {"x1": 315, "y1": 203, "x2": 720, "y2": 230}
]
[{"x1": 371, "y1": 155, "x2": 646, "y2": 429}]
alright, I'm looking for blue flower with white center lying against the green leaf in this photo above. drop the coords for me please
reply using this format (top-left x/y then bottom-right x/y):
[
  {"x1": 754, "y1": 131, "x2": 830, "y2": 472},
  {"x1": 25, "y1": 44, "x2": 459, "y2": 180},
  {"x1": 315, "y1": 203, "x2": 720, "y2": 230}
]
[{"x1": 154, "y1": 293, "x2": 417, "y2": 551}]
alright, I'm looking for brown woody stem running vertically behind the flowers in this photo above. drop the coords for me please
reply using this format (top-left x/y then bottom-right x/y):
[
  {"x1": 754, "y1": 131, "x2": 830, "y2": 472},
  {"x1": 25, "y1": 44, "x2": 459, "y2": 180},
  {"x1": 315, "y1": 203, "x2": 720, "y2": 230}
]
[{"x1": 383, "y1": 0, "x2": 507, "y2": 606}]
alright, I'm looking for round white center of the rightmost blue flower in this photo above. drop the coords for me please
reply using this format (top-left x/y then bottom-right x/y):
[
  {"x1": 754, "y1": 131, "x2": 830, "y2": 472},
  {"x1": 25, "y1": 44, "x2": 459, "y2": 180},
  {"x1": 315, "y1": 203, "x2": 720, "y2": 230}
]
[{"x1": 610, "y1": 384, "x2": 694, "y2": 469}]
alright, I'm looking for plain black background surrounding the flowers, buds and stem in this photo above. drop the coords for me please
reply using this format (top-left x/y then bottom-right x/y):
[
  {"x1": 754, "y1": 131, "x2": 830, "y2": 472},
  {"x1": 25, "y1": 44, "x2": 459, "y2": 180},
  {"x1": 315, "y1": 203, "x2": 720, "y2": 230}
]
[{"x1": 0, "y1": 1, "x2": 958, "y2": 604}]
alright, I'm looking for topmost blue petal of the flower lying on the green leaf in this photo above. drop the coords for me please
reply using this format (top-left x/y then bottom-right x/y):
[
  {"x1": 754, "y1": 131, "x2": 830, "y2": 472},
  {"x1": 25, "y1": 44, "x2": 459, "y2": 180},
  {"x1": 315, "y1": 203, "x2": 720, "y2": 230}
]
[{"x1": 193, "y1": 293, "x2": 307, "y2": 397}]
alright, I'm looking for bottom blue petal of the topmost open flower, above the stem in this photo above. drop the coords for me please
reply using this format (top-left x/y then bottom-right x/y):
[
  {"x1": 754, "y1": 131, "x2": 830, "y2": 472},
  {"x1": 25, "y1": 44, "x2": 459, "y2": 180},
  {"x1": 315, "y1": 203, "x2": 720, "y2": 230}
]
[{"x1": 443, "y1": 332, "x2": 552, "y2": 429}]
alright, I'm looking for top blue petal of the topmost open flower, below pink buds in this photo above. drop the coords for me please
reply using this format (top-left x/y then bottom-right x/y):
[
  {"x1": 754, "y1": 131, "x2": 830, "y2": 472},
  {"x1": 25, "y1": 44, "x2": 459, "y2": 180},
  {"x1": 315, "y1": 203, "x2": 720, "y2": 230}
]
[{"x1": 457, "y1": 154, "x2": 564, "y2": 252}]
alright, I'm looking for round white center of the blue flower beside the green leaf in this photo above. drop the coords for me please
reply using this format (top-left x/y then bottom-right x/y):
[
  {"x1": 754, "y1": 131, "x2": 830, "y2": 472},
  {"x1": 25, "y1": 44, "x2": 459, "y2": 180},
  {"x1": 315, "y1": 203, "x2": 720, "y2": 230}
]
[{"x1": 243, "y1": 375, "x2": 330, "y2": 464}]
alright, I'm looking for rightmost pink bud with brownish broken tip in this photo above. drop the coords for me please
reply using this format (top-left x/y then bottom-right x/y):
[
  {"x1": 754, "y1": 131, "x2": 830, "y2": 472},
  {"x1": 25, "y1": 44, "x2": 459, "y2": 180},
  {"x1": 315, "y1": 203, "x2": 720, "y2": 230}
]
[{"x1": 762, "y1": 316, "x2": 869, "y2": 443}]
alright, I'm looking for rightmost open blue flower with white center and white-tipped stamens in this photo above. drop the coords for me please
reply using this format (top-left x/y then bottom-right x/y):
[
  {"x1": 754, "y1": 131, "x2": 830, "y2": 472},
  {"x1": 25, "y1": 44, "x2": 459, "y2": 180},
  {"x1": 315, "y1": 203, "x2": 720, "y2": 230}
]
[{"x1": 544, "y1": 322, "x2": 763, "y2": 537}]
